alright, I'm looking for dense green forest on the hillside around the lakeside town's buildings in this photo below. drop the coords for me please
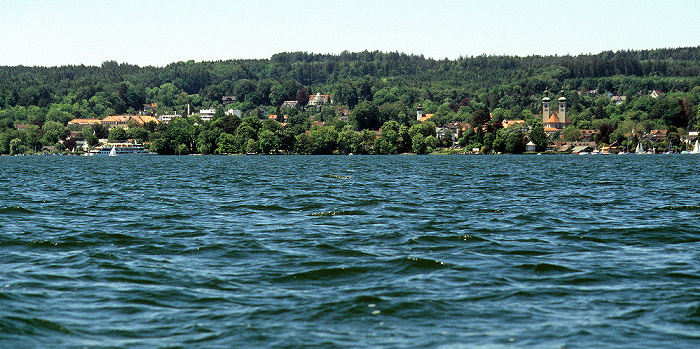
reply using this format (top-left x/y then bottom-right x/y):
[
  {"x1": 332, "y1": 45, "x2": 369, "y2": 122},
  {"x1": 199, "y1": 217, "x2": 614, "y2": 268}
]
[{"x1": 0, "y1": 47, "x2": 700, "y2": 154}]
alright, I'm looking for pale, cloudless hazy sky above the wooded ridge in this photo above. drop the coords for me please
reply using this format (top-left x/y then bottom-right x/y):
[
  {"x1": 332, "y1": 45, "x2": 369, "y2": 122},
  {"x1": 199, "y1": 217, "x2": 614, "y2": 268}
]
[{"x1": 0, "y1": 0, "x2": 700, "y2": 66}]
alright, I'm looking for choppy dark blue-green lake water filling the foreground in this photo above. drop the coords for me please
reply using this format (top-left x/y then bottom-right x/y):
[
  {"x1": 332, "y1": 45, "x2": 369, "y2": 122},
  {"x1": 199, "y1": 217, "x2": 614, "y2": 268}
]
[{"x1": 0, "y1": 155, "x2": 700, "y2": 348}]
